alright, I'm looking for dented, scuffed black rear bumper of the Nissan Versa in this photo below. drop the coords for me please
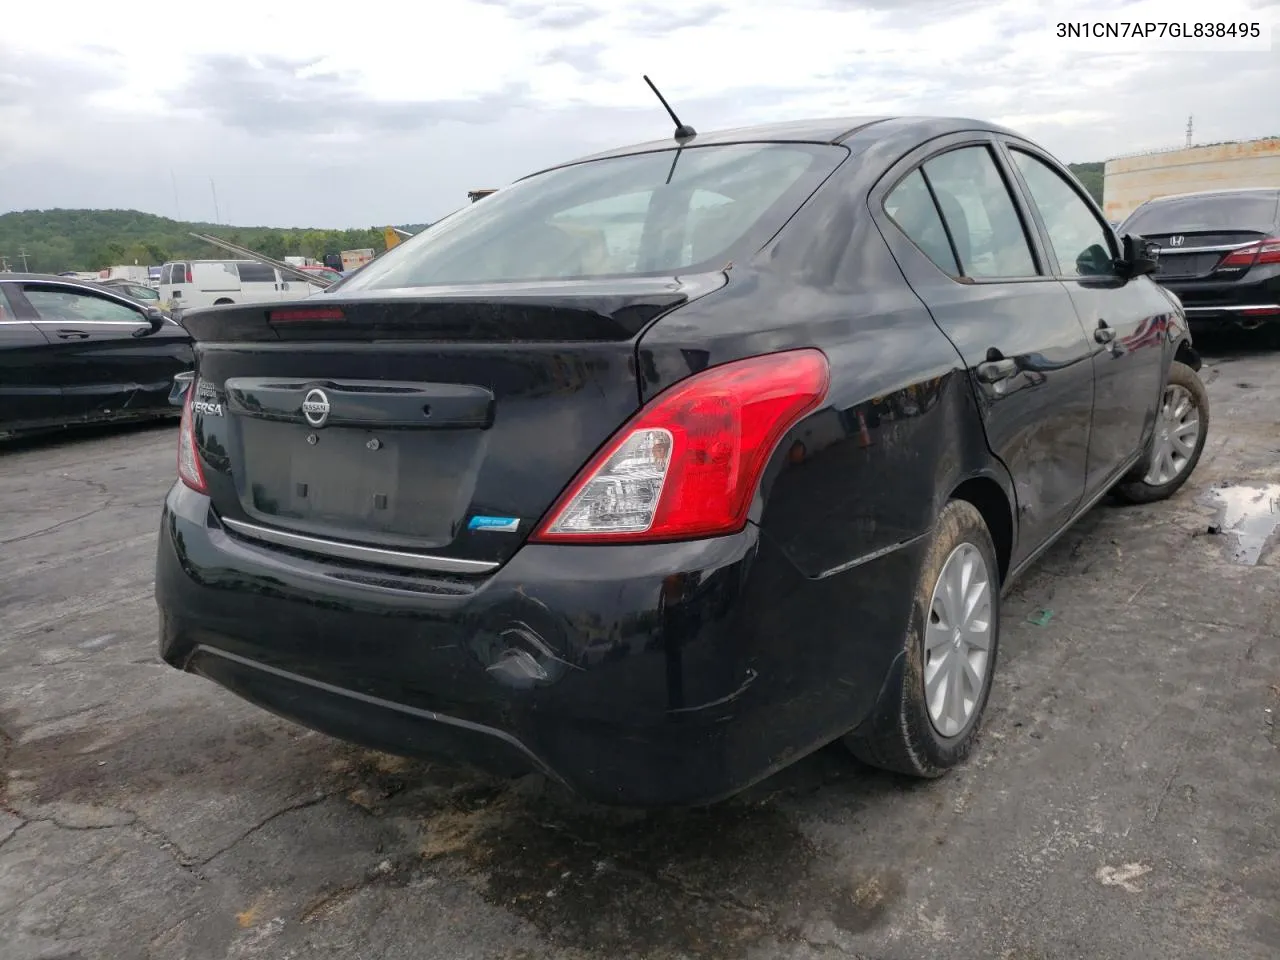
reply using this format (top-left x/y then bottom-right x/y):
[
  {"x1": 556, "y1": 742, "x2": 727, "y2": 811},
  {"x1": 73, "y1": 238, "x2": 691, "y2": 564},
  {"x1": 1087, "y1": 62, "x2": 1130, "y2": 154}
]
[{"x1": 156, "y1": 484, "x2": 920, "y2": 805}]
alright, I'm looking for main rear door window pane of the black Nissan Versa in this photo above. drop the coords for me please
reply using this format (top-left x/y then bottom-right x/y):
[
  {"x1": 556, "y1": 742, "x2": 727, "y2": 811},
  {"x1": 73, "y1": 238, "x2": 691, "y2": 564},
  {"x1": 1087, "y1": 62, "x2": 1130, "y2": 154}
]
[{"x1": 923, "y1": 146, "x2": 1038, "y2": 279}]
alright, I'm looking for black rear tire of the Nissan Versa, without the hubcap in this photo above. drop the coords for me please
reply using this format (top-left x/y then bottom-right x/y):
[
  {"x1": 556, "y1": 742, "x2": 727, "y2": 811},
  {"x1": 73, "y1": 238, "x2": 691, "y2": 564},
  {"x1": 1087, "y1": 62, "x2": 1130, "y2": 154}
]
[{"x1": 845, "y1": 500, "x2": 1000, "y2": 778}]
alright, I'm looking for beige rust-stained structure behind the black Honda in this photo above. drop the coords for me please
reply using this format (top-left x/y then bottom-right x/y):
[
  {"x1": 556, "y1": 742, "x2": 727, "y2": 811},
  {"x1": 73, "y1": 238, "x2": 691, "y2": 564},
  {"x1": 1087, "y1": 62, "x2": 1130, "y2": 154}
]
[{"x1": 1102, "y1": 137, "x2": 1280, "y2": 223}]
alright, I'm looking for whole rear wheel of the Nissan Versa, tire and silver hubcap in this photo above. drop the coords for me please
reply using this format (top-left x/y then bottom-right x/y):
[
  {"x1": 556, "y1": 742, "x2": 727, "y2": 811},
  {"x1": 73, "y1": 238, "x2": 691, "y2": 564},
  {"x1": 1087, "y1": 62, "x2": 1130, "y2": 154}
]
[{"x1": 845, "y1": 500, "x2": 1000, "y2": 777}]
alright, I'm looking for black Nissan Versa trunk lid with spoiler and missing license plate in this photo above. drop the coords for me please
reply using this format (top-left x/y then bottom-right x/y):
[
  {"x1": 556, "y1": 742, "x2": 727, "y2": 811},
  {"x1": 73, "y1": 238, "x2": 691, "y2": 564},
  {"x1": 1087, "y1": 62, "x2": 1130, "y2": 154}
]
[{"x1": 184, "y1": 274, "x2": 724, "y2": 572}]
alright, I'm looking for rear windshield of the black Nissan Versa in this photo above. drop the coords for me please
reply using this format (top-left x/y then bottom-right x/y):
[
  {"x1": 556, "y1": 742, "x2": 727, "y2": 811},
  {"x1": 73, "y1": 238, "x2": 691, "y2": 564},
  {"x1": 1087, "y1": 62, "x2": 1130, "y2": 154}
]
[{"x1": 343, "y1": 143, "x2": 847, "y2": 291}]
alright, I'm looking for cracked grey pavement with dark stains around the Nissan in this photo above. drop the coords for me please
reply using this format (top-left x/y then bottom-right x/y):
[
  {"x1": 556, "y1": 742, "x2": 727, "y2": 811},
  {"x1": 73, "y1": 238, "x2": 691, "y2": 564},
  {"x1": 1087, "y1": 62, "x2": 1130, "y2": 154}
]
[{"x1": 0, "y1": 340, "x2": 1280, "y2": 960}]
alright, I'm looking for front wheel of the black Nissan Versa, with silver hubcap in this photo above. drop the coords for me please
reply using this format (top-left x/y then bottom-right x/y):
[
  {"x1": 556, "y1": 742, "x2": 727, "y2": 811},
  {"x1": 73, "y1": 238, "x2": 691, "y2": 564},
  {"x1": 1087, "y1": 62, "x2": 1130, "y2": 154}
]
[{"x1": 1115, "y1": 362, "x2": 1208, "y2": 503}]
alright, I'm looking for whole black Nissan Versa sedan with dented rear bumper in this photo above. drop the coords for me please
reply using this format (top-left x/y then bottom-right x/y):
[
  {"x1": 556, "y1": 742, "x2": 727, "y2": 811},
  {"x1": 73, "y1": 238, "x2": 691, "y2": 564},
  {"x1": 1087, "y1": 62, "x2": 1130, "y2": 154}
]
[{"x1": 156, "y1": 118, "x2": 1208, "y2": 805}]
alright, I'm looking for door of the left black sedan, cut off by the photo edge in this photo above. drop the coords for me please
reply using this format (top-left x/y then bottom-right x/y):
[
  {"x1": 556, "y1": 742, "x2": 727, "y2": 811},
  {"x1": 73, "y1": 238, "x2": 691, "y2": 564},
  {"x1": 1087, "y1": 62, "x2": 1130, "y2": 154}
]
[{"x1": 0, "y1": 283, "x2": 67, "y2": 433}]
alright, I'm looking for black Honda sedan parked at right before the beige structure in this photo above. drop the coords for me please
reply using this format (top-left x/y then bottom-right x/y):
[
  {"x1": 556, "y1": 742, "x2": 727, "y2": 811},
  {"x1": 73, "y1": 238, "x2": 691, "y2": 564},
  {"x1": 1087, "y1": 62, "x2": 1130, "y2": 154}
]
[{"x1": 1121, "y1": 188, "x2": 1280, "y2": 332}]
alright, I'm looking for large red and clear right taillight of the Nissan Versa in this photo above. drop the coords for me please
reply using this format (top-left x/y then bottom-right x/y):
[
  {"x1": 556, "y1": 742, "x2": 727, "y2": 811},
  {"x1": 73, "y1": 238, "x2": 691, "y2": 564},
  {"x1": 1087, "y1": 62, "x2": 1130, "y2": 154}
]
[{"x1": 531, "y1": 349, "x2": 829, "y2": 543}]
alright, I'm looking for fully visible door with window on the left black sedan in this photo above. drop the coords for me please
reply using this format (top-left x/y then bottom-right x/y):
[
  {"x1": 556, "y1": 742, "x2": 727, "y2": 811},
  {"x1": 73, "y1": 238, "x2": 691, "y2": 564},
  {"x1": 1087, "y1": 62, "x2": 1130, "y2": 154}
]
[{"x1": 12, "y1": 282, "x2": 151, "y2": 419}]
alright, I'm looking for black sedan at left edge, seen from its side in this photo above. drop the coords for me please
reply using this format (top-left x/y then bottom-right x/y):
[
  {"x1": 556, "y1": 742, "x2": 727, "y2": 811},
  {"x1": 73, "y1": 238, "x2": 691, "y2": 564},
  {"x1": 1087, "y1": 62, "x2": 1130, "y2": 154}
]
[{"x1": 0, "y1": 274, "x2": 192, "y2": 436}]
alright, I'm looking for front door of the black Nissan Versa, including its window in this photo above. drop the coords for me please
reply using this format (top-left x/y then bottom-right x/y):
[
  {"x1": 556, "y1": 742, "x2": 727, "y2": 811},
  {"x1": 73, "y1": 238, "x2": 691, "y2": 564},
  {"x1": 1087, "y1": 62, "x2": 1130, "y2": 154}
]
[{"x1": 1005, "y1": 141, "x2": 1171, "y2": 495}]
